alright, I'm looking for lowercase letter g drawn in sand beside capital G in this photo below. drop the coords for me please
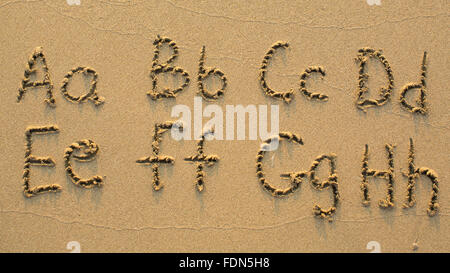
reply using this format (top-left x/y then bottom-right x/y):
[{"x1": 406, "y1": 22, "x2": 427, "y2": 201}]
[{"x1": 309, "y1": 154, "x2": 340, "y2": 221}]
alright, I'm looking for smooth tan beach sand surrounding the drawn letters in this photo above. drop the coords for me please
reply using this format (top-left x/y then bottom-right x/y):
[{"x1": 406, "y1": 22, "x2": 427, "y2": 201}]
[{"x1": 0, "y1": 0, "x2": 450, "y2": 252}]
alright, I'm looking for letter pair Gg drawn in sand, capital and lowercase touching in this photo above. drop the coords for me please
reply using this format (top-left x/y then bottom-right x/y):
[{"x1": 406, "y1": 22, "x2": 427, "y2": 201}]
[{"x1": 256, "y1": 132, "x2": 340, "y2": 221}]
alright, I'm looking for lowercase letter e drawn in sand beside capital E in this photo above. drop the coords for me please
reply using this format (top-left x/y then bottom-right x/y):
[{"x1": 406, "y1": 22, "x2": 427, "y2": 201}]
[{"x1": 64, "y1": 139, "x2": 103, "y2": 189}]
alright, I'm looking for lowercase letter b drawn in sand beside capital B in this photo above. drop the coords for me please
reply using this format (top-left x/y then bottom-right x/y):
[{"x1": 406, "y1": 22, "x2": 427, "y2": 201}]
[{"x1": 197, "y1": 46, "x2": 227, "y2": 100}]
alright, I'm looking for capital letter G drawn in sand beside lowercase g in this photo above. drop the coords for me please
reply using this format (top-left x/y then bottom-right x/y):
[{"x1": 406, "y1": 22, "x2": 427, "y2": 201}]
[{"x1": 256, "y1": 132, "x2": 307, "y2": 197}]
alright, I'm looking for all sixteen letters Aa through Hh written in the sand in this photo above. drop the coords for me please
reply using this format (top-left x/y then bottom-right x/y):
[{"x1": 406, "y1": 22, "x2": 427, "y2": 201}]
[{"x1": 17, "y1": 35, "x2": 439, "y2": 221}]
